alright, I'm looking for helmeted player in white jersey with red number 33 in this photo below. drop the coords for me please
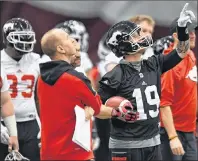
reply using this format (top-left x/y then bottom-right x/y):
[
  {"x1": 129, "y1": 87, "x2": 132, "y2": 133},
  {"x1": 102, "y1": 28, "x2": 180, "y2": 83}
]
[{"x1": 0, "y1": 18, "x2": 41, "y2": 160}]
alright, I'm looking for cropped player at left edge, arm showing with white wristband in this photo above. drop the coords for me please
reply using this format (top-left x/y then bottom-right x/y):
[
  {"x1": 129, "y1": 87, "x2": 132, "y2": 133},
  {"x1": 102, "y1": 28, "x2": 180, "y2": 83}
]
[{"x1": 0, "y1": 66, "x2": 19, "y2": 153}]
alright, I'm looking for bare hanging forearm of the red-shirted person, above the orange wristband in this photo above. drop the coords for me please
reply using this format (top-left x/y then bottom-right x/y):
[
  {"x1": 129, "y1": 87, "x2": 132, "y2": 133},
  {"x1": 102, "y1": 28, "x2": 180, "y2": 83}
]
[{"x1": 160, "y1": 106, "x2": 177, "y2": 138}]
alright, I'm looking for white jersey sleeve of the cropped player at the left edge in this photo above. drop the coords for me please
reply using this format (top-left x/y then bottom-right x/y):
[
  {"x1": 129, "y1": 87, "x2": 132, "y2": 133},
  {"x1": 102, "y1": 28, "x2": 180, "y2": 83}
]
[{"x1": 0, "y1": 64, "x2": 9, "y2": 92}]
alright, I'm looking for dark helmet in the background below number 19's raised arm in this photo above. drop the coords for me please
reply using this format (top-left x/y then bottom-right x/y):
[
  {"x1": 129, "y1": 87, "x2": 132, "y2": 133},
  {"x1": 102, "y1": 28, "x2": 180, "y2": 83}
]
[{"x1": 152, "y1": 36, "x2": 174, "y2": 55}]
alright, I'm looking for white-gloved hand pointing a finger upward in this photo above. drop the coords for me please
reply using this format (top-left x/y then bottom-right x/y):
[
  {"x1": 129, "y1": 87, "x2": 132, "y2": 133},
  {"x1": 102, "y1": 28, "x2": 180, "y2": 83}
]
[{"x1": 177, "y1": 3, "x2": 196, "y2": 27}]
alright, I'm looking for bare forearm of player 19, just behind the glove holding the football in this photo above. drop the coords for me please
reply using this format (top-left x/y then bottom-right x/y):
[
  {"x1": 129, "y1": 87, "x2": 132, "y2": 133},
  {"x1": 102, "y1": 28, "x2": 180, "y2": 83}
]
[{"x1": 96, "y1": 105, "x2": 113, "y2": 119}]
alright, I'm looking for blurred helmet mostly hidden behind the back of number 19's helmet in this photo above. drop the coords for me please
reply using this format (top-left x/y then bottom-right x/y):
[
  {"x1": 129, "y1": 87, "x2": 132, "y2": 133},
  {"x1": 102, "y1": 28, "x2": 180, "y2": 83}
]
[{"x1": 98, "y1": 33, "x2": 111, "y2": 60}]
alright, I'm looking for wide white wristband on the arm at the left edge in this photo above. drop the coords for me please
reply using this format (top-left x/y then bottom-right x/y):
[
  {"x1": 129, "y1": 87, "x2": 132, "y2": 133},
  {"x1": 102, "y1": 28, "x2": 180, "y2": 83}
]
[{"x1": 3, "y1": 115, "x2": 17, "y2": 136}]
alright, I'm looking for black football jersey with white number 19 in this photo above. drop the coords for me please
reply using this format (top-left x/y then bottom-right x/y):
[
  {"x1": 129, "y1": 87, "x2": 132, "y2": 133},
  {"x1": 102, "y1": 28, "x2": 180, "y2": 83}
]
[{"x1": 98, "y1": 56, "x2": 164, "y2": 141}]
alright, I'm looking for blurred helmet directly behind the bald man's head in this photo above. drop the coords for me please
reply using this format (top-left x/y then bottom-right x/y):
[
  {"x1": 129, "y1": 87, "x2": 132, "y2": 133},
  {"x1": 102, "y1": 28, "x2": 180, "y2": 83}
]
[{"x1": 55, "y1": 20, "x2": 89, "y2": 52}]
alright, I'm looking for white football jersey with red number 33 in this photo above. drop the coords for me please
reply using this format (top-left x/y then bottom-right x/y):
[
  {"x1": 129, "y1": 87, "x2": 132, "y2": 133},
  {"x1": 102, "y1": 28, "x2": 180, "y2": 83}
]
[{"x1": 1, "y1": 50, "x2": 41, "y2": 122}]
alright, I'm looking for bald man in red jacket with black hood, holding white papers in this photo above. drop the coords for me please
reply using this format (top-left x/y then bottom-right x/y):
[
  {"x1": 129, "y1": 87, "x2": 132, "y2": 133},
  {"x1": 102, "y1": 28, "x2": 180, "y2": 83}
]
[{"x1": 38, "y1": 29, "x2": 137, "y2": 160}]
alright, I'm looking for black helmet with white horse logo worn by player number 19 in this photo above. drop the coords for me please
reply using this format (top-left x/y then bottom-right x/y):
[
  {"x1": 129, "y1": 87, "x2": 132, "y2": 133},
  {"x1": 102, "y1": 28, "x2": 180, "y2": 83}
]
[{"x1": 106, "y1": 21, "x2": 153, "y2": 57}]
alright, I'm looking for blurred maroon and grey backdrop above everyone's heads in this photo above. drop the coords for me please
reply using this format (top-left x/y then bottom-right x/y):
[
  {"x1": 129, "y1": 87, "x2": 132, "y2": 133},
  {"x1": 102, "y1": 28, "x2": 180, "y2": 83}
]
[{"x1": 0, "y1": 0, "x2": 198, "y2": 63}]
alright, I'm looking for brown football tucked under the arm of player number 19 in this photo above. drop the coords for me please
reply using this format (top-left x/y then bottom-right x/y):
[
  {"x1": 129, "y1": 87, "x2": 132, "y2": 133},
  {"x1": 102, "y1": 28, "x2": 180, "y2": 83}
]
[{"x1": 105, "y1": 96, "x2": 129, "y2": 108}]
